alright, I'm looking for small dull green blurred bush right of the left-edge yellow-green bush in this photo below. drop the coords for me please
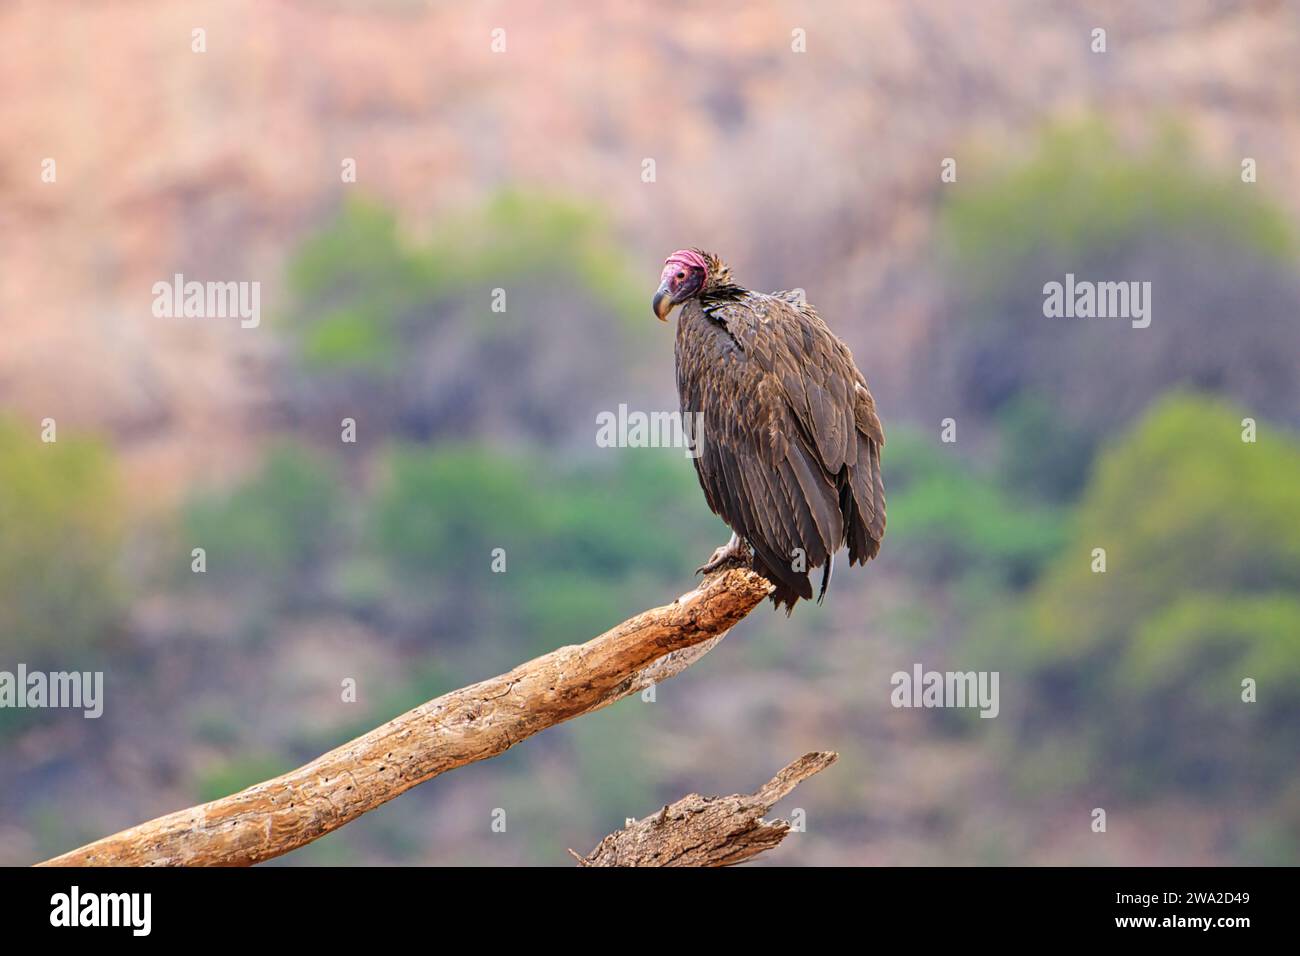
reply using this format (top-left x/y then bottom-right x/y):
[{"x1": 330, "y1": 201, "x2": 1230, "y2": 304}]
[{"x1": 185, "y1": 445, "x2": 345, "y2": 587}]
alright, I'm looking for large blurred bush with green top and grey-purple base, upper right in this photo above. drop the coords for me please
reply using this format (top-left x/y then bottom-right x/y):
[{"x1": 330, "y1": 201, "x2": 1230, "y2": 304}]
[{"x1": 923, "y1": 121, "x2": 1300, "y2": 502}]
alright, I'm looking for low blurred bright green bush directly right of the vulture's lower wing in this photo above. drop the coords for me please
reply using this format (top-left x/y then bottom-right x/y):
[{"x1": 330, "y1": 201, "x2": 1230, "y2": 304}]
[{"x1": 884, "y1": 429, "x2": 1062, "y2": 585}]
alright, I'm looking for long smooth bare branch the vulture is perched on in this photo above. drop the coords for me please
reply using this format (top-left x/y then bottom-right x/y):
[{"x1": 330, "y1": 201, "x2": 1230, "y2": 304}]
[{"x1": 43, "y1": 568, "x2": 772, "y2": 866}]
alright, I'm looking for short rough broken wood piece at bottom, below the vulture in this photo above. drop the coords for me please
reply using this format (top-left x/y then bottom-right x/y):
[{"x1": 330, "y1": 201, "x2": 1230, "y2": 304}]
[{"x1": 569, "y1": 750, "x2": 839, "y2": 866}]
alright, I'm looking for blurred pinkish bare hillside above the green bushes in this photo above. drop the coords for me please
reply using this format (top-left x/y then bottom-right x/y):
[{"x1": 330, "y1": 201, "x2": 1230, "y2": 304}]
[{"x1": 0, "y1": 0, "x2": 1300, "y2": 497}]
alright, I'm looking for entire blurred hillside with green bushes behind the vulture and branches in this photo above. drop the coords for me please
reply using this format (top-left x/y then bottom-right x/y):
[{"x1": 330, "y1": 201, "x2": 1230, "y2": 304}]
[{"x1": 0, "y1": 0, "x2": 1300, "y2": 865}]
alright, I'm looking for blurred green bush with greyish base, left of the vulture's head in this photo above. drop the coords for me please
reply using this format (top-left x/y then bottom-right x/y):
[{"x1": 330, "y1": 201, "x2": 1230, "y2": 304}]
[{"x1": 280, "y1": 190, "x2": 653, "y2": 441}]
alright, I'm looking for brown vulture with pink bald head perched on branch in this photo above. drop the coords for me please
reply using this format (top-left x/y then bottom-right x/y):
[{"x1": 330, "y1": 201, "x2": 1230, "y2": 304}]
[{"x1": 653, "y1": 248, "x2": 885, "y2": 614}]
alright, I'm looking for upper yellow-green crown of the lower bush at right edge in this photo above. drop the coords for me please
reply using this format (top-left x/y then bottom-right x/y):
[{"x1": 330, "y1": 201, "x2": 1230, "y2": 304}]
[{"x1": 1034, "y1": 395, "x2": 1300, "y2": 653}]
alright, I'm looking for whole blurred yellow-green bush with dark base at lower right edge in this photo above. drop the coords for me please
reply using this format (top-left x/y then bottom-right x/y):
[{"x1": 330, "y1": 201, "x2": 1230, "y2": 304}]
[{"x1": 989, "y1": 394, "x2": 1300, "y2": 792}]
